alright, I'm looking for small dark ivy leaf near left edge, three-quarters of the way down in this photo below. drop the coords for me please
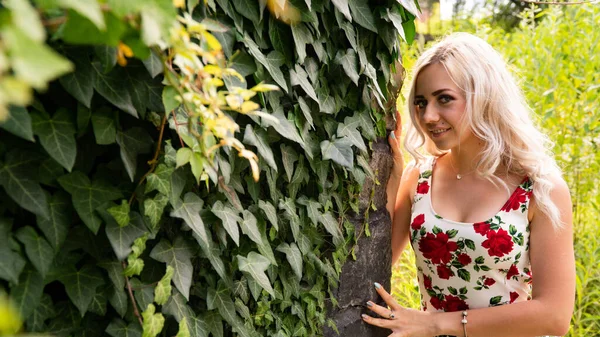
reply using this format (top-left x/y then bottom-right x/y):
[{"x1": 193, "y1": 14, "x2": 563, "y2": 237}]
[{"x1": 15, "y1": 226, "x2": 54, "y2": 278}]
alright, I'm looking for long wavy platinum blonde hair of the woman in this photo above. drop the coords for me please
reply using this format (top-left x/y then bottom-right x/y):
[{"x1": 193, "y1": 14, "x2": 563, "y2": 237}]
[{"x1": 404, "y1": 33, "x2": 563, "y2": 228}]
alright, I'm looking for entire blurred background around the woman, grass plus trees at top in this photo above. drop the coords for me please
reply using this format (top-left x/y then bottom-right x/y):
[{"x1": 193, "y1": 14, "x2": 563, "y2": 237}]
[{"x1": 392, "y1": 0, "x2": 600, "y2": 337}]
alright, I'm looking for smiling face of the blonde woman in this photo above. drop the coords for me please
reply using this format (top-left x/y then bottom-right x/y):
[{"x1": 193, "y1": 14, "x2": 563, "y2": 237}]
[{"x1": 413, "y1": 63, "x2": 474, "y2": 150}]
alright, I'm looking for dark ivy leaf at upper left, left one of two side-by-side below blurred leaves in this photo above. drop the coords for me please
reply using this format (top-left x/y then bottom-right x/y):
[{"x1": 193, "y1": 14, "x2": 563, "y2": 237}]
[{"x1": 58, "y1": 53, "x2": 96, "y2": 109}]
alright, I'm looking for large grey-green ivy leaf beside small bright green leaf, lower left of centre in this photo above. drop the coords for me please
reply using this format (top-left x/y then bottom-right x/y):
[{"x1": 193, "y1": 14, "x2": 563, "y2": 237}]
[{"x1": 150, "y1": 236, "x2": 194, "y2": 299}]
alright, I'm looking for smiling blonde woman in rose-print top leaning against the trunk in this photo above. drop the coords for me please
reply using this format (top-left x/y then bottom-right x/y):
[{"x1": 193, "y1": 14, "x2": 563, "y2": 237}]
[{"x1": 363, "y1": 33, "x2": 575, "y2": 337}]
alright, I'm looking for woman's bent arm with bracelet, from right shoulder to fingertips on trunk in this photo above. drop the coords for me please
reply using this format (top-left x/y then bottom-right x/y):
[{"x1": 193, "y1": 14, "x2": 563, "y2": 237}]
[{"x1": 364, "y1": 178, "x2": 575, "y2": 337}]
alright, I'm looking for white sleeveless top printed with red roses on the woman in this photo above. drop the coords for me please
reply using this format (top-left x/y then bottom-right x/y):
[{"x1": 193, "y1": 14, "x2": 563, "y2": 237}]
[{"x1": 410, "y1": 157, "x2": 532, "y2": 311}]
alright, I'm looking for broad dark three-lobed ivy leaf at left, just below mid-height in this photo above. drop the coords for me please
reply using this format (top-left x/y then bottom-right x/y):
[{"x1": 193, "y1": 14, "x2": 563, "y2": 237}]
[{"x1": 58, "y1": 171, "x2": 122, "y2": 234}]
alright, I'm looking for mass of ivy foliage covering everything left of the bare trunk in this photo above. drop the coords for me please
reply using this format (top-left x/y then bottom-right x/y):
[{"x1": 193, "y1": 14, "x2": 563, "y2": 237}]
[{"x1": 0, "y1": 0, "x2": 414, "y2": 337}]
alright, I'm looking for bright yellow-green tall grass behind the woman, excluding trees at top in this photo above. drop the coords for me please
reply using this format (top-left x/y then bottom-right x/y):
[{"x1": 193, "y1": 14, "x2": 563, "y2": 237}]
[{"x1": 393, "y1": 5, "x2": 600, "y2": 337}]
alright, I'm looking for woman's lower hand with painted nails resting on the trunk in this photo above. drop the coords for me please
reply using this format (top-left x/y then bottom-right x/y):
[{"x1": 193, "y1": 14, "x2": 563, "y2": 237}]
[{"x1": 362, "y1": 283, "x2": 435, "y2": 337}]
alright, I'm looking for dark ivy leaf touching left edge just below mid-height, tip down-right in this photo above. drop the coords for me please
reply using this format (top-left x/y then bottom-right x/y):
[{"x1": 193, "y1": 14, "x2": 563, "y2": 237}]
[{"x1": 0, "y1": 150, "x2": 50, "y2": 218}]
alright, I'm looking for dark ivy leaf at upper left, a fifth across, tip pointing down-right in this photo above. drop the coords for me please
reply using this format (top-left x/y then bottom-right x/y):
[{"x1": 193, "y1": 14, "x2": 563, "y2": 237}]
[{"x1": 92, "y1": 62, "x2": 138, "y2": 118}]
